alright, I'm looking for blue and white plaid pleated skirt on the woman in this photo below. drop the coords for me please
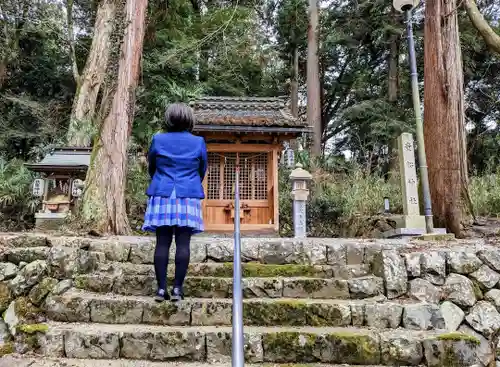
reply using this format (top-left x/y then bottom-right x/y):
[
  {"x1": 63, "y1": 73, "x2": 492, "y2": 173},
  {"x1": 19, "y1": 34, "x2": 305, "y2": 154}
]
[{"x1": 142, "y1": 190, "x2": 204, "y2": 234}]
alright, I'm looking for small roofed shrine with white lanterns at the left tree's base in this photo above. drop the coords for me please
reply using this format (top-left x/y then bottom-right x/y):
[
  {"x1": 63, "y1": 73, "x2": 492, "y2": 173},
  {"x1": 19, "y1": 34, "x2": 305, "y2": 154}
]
[{"x1": 26, "y1": 148, "x2": 92, "y2": 229}]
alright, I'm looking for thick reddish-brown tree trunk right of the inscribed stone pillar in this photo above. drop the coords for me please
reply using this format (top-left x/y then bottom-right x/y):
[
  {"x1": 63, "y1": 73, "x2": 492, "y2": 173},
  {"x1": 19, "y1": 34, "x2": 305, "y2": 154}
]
[{"x1": 424, "y1": 0, "x2": 468, "y2": 237}]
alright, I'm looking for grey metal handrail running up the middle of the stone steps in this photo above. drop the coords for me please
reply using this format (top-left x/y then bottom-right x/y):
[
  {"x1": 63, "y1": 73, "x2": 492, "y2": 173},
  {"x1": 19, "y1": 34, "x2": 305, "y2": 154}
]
[{"x1": 232, "y1": 165, "x2": 245, "y2": 367}]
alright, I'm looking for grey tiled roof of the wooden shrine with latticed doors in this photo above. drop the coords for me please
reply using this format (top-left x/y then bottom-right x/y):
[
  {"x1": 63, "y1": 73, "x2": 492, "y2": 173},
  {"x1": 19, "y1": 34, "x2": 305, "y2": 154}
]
[{"x1": 191, "y1": 97, "x2": 307, "y2": 129}]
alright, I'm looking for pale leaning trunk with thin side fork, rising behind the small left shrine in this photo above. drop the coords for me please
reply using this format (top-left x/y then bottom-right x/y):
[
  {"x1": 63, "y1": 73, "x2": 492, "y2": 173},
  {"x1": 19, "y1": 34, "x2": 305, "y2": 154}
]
[{"x1": 67, "y1": 0, "x2": 117, "y2": 147}]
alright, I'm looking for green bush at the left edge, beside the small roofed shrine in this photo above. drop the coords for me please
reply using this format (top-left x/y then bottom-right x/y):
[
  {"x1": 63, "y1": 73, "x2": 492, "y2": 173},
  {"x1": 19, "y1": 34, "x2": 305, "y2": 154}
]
[{"x1": 0, "y1": 157, "x2": 40, "y2": 231}]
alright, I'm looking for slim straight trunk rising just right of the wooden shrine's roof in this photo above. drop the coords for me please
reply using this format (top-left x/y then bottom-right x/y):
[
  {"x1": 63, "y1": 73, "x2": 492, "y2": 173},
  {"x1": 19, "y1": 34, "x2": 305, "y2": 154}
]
[{"x1": 307, "y1": 0, "x2": 322, "y2": 157}]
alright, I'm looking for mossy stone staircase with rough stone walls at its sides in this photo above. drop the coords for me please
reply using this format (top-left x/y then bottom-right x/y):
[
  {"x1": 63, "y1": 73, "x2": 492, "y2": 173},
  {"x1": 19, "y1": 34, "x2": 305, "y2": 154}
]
[{"x1": 0, "y1": 234, "x2": 500, "y2": 367}]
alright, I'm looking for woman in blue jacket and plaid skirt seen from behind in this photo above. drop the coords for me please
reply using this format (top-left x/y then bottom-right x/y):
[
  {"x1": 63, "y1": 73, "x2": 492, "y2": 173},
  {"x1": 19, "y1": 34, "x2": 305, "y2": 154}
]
[{"x1": 143, "y1": 103, "x2": 207, "y2": 302}]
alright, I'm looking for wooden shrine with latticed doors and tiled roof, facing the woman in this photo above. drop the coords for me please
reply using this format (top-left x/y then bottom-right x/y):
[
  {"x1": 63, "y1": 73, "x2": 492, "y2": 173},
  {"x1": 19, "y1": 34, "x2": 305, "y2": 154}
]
[{"x1": 191, "y1": 97, "x2": 310, "y2": 232}]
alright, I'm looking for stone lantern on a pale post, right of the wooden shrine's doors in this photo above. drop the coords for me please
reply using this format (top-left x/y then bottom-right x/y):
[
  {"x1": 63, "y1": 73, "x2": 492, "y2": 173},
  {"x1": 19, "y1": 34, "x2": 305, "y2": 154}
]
[{"x1": 290, "y1": 163, "x2": 312, "y2": 238}]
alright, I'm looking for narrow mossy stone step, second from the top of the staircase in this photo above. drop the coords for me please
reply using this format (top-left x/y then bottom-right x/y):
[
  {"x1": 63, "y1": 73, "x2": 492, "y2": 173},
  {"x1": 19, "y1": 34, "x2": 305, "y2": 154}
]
[{"x1": 96, "y1": 261, "x2": 370, "y2": 279}]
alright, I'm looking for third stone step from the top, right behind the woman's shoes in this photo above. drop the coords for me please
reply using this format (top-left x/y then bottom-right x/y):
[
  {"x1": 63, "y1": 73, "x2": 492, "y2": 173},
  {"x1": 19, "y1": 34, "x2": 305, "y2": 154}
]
[{"x1": 74, "y1": 273, "x2": 384, "y2": 299}]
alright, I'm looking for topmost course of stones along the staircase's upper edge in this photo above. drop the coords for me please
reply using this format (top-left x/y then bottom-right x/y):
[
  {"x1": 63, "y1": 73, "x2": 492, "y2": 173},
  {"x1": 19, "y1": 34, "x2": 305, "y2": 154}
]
[{"x1": 0, "y1": 234, "x2": 410, "y2": 265}]
